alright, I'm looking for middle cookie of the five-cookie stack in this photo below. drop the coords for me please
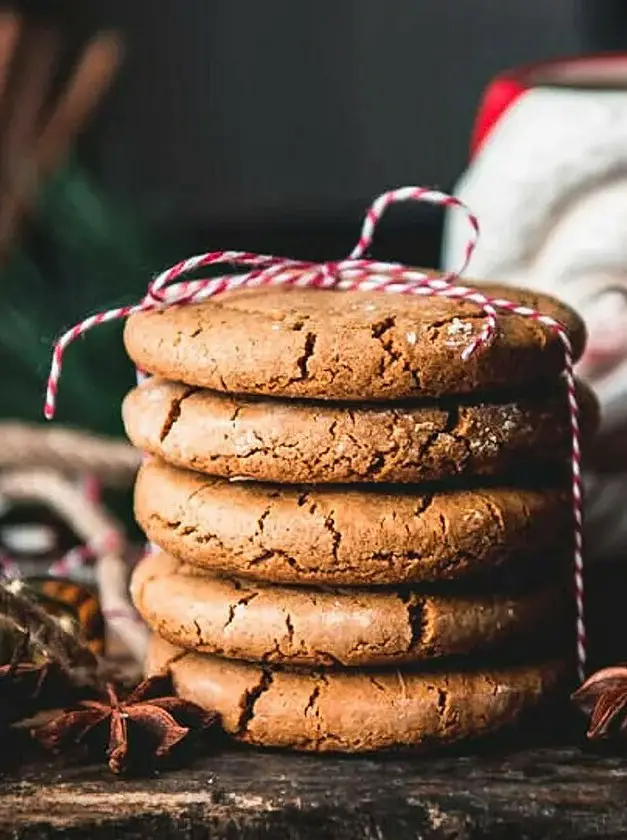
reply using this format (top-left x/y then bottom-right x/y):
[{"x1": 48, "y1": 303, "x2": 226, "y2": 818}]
[{"x1": 134, "y1": 459, "x2": 572, "y2": 586}]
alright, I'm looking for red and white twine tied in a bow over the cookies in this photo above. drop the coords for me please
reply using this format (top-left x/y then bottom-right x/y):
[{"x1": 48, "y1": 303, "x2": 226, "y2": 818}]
[{"x1": 44, "y1": 187, "x2": 586, "y2": 679}]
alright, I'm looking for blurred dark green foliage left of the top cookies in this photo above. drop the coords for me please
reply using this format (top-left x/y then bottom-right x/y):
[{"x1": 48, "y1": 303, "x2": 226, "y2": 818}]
[{"x1": 0, "y1": 165, "x2": 166, "y2": 435}]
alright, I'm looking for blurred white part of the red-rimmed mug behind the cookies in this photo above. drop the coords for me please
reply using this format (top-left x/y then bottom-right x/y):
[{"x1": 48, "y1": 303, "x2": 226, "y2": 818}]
[{"x1": 443, "y1": 83, "x2": 627, "y2": 560}]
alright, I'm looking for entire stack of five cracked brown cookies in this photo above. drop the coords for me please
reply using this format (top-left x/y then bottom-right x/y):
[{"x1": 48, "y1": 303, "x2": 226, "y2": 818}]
[{"x1": 123, "y1": 278, "x2": 596, "y2": 752}]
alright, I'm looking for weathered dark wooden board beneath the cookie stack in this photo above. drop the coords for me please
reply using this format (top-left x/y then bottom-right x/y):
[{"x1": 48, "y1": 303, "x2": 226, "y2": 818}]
[{"x1": 0, "y1": 746, "x2": 627, "y2": 840}]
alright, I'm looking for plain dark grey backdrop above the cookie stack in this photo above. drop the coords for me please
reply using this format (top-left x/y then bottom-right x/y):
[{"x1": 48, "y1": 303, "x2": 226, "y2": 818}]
[{"x1": 78, "y1": 0, "x2": 627, "y2": 263}]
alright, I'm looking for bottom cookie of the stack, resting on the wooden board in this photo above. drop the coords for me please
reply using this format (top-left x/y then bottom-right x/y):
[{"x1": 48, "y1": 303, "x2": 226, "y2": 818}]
[{"x1": 146, "y1": 637, "x2": 568, "y2": 753}]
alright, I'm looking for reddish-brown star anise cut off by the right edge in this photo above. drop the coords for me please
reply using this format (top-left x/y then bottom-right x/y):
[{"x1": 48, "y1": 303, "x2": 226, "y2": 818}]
[{"x1": 572, "y1": 665, "x2": 627, "y2": 740}]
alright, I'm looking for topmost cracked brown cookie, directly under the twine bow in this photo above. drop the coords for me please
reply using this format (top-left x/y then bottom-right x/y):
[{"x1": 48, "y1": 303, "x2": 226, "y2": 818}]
[{"x1": 124, "y1": 281, "x2": 585, "y2": 400}]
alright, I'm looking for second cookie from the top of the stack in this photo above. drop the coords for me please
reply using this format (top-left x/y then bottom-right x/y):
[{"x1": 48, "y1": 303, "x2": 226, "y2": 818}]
[{"x1": 122, "y1": 377, "x2": 597, "y2": 483}]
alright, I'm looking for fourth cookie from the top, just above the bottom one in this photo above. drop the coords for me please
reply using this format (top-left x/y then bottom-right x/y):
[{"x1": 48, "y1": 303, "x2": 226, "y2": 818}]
[{"x1": 131, "y1": 553, "x2": 572, "y2": 667}]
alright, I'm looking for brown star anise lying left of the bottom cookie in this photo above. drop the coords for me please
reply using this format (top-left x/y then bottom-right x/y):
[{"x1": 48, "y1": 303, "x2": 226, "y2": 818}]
[{"x1": 33, "y1": 674, "x2": 219, "y2": 773}]
